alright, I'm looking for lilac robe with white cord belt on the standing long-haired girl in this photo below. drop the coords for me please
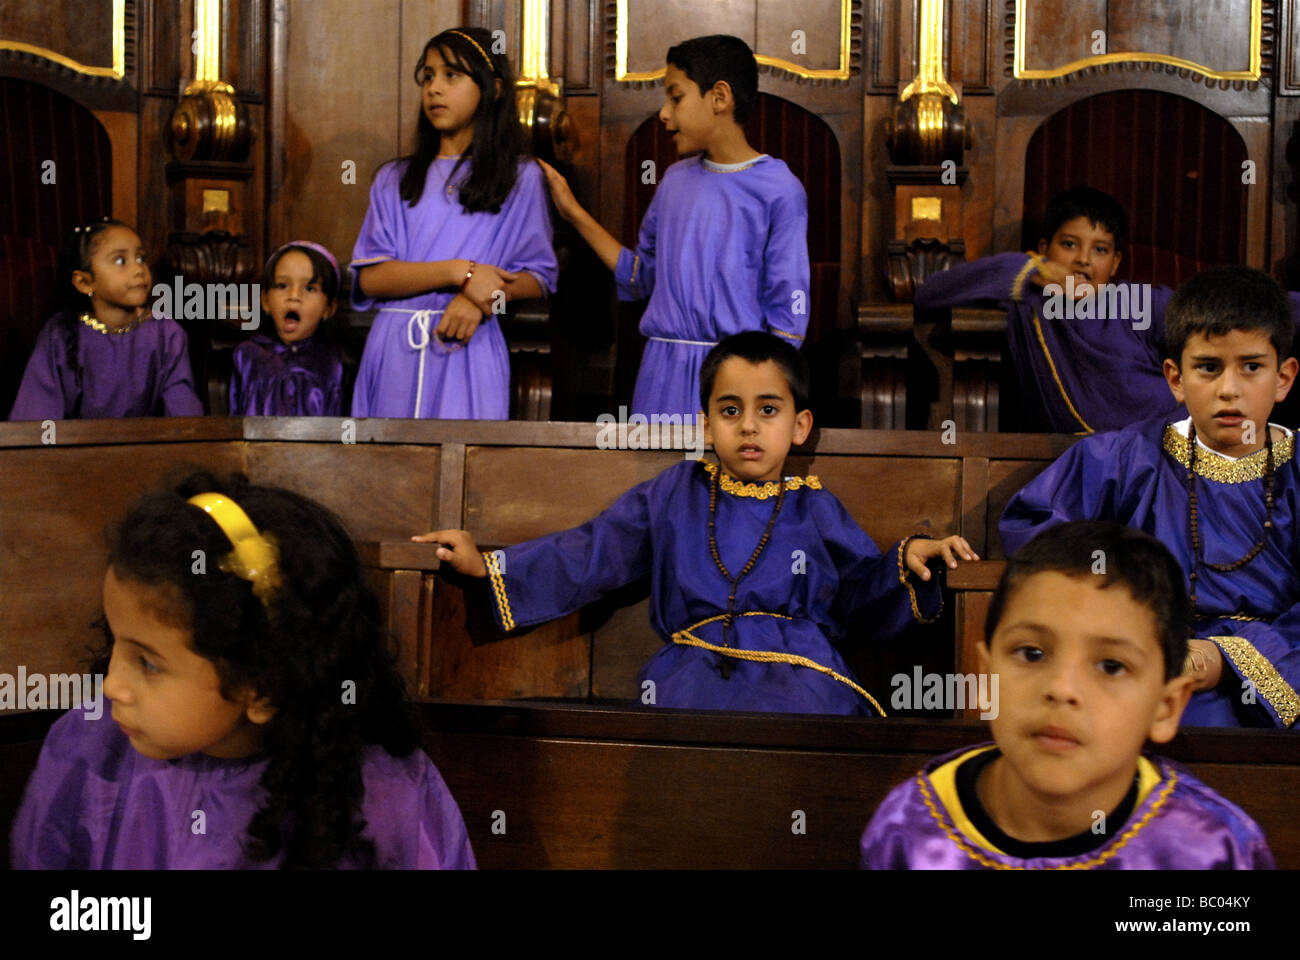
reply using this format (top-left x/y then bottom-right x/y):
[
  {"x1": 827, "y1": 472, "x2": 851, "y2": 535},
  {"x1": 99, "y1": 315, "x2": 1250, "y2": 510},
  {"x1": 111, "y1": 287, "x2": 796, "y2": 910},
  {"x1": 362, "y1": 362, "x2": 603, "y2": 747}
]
[{"x1": 350, "y1": 157, "x2": 559, "y2": 420}]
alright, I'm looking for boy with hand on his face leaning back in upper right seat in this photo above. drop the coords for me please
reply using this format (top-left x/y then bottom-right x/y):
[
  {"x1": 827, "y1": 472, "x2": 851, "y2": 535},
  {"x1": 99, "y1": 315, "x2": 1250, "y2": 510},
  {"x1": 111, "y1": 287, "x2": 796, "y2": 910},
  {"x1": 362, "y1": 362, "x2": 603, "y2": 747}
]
[{"x1": 915, "y1": 187, "x2": 1178, "y2": 433}]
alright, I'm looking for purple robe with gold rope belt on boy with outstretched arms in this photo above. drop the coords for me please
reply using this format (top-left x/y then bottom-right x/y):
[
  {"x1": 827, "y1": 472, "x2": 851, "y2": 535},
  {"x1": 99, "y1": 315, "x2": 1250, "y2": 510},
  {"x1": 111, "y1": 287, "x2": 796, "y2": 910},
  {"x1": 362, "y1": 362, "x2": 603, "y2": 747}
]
[{"x1": 484, "y1": 460, "x2": 943, "y2": 714}]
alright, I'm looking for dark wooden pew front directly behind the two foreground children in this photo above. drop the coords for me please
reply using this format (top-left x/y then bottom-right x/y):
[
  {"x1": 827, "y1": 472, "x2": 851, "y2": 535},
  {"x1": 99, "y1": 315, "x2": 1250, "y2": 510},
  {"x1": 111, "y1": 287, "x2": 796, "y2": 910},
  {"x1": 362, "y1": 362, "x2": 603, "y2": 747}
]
[{"x1": 0, "y1": 700, "x2": 1300, "y2": 869}]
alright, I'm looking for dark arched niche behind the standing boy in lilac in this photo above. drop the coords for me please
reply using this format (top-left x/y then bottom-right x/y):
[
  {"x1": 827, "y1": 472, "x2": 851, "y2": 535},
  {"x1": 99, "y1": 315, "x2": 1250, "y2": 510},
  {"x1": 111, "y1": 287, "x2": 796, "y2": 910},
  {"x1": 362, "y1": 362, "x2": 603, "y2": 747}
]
[{"x1": 620, "y1": 92, "x2": 842, "y2": 411}]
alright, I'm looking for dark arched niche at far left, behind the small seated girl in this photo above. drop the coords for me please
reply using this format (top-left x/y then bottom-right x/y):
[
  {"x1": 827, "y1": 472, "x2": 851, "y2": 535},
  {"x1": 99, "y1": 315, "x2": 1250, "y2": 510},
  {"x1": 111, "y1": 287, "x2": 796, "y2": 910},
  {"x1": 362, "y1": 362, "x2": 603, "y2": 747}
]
[{"x1": 0, "y1": 77, "x2": 113, "y2": 415}]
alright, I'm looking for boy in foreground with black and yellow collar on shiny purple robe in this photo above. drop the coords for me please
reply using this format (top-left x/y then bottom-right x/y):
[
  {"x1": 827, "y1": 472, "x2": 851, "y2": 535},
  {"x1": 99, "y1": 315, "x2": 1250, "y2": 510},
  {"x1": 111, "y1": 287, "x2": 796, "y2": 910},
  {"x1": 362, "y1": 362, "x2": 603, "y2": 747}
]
[{"x1": 862, "y1": 520, "x2": 1274, "y2": 870}]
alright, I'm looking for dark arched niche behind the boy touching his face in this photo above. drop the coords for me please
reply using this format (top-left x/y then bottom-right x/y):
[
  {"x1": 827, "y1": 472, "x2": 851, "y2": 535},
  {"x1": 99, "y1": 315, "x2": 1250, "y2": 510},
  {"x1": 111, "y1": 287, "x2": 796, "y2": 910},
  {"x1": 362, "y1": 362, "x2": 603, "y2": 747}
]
[{"x1": 1023, "y1": 90, "x2": 1247, "y2": 286}]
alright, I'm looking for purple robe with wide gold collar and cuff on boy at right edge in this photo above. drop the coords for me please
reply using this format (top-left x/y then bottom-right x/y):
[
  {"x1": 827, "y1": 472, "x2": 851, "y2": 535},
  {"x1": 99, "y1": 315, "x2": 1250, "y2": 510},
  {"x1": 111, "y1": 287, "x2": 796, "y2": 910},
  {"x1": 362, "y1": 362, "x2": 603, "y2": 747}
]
[{"x1": 998, "y1": 418, "x2": 1300, "y2": 728}]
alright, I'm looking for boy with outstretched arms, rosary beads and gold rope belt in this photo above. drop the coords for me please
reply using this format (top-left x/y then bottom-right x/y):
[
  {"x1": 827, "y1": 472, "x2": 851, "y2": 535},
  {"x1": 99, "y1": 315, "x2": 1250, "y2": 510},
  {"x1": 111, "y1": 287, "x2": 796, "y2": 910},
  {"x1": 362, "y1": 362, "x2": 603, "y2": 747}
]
[{"x1": 413, "y1": 330, "x2": 978, "y2": 715}]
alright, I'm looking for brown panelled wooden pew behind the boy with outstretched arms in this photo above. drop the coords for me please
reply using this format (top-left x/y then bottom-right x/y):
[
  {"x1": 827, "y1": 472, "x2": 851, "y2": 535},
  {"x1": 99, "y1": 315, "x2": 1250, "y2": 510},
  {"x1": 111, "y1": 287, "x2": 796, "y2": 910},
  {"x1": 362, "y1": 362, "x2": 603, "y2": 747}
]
[{"x1": 0, "y1": 418, "x2": 1073, "y2": 699}]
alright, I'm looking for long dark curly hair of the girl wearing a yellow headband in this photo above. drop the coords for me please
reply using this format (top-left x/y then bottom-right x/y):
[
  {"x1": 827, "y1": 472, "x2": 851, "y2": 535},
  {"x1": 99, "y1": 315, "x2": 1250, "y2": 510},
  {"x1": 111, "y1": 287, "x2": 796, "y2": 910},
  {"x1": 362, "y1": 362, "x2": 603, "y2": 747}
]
[{"x1": 98, "y1": 473, "x2": 420, "y2": 869}]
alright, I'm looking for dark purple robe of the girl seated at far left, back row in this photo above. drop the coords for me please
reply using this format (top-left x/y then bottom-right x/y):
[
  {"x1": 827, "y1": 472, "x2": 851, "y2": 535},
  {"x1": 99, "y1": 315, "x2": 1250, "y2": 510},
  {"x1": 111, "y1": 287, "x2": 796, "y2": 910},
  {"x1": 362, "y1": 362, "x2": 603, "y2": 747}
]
[{"x1": 9, "y1": 313, "x2": 203, "y2": 420}]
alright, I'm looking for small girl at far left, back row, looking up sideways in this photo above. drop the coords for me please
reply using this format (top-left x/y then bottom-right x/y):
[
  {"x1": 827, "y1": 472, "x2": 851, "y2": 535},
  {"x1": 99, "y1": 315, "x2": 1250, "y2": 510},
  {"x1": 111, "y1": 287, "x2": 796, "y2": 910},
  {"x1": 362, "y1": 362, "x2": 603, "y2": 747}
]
[{"x1": 9, "y1": 217, "x2": 203, "y2": 420}]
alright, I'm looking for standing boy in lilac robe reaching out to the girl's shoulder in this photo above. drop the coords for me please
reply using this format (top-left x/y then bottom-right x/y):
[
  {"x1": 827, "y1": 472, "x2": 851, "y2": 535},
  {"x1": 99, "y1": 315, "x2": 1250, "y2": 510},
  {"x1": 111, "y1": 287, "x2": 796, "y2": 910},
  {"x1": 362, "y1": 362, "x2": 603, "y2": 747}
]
[{"x1": 542, "y1": 35, "x2": 809, "y2": 416}]
